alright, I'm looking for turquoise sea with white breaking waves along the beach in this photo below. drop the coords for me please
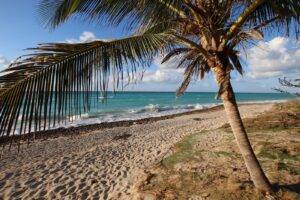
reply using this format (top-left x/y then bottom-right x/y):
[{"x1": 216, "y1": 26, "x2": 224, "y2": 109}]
[{"x1": 68, "y1": 92, "x2": 295, "y2": 125}]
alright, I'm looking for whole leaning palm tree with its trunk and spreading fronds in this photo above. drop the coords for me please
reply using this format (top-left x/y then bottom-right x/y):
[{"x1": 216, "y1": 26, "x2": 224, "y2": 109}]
[{"x1": 0, "y1": 0, "x2": 300, "y2": 193}]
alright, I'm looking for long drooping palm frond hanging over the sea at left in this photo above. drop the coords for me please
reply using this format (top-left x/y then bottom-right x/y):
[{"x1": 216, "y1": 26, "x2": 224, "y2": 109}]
[{"x1": 0, "y1": 33, "x2": 170, "y2": 145}]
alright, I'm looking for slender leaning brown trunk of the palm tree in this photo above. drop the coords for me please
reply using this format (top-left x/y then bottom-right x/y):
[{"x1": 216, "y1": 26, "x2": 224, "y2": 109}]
[{"x1": 213, "y1": 64, "x2": 273, "y2": 193}]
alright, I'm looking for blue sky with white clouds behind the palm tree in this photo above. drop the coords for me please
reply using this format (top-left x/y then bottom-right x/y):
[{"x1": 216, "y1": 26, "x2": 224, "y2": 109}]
[{"x1": 0, "y1": 0, "x2": 300, "y2": 92}]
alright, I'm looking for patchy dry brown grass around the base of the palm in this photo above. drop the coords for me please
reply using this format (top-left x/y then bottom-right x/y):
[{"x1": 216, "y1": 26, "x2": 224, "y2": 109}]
[{"x1": 140, "y1": 101, "x2": 300, "y2": 200}]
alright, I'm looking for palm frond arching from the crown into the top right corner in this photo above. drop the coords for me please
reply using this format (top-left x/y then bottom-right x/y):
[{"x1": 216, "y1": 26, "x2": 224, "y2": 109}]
[{"x1": 225, "y1": 0, "x2": 300, "y2": 42}]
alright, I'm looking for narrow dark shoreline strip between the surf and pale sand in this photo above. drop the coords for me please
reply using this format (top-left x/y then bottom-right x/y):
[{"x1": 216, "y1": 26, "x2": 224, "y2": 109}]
[{"x1": 0, "y1": 100, "x2": 286, "y2": 146}]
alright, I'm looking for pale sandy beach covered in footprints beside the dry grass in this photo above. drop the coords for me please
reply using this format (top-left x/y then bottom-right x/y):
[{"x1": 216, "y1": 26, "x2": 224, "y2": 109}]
[{"x1": 0, "y1": 103, "x2": 274, "y2": 200}]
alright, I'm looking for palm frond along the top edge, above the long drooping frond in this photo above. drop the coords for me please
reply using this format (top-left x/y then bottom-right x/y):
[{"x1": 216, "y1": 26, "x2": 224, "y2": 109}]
[{"x1": 38, "y1": 0, "x2": 184, "y2": 27}]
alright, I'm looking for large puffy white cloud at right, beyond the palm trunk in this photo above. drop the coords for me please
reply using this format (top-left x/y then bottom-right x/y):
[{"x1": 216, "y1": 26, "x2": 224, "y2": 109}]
[{"x1": 247, "y1": 37, "x2": 300, "y2": 78}]
